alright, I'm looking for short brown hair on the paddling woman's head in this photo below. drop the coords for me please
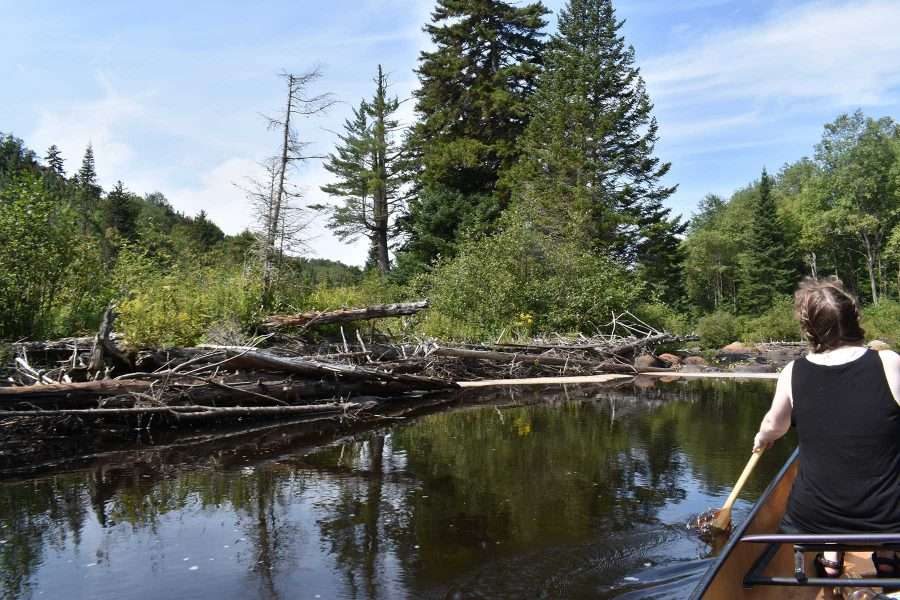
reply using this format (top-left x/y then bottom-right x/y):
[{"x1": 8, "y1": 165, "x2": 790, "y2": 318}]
[{"x1": 794, "y1": 276, "x2": 865, "y2": 352}]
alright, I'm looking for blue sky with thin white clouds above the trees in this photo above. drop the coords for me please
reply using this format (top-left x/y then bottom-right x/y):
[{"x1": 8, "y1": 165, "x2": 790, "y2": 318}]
[{"x1": 0, "y1": 0, "x2": 900, "y2": 265}]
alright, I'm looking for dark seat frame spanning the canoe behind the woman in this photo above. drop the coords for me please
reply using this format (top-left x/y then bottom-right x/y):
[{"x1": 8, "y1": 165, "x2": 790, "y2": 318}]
[{"x1": 740, "y1": 533, "x2": 900, "y2": 587}]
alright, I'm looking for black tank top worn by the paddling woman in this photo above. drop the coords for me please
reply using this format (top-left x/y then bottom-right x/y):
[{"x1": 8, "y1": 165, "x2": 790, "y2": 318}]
[{"x1": 787, "y1": 350, "x2": 900, "y2": 533}]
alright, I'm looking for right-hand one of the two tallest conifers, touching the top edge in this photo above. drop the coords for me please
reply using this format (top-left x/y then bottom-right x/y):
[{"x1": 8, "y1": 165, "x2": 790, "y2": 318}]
[{"x1": 512, "y1": 0, "x2": 684, "y2": 264}]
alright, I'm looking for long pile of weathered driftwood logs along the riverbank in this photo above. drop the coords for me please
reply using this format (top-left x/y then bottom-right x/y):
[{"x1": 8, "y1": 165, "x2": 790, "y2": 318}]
[{"x1": 0, "y1": 302, "x2": 683, "y2": 434}]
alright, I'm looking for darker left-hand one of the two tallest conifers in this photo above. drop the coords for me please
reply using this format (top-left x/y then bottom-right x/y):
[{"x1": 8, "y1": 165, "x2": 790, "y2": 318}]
[{"x1": 404, "y1": 0, "x2": 547, "y2": 263}]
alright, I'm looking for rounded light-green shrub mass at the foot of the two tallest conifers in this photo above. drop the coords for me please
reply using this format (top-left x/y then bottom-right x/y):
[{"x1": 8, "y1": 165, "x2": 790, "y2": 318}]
[{"x1": 419, "y1": 213, "x2": 642, "y2": 339}]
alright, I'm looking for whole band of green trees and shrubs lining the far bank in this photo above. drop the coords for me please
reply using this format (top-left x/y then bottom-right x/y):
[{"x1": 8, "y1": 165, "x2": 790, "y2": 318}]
[{"x1": 0, "y1": 0, "x2": 900, "y2": 347}]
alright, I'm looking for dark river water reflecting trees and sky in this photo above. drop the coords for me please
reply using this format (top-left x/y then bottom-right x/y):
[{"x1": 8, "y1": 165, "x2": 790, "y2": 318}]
[{"x1": 0, "y1": 382, "x2": 791, "y2": 600}]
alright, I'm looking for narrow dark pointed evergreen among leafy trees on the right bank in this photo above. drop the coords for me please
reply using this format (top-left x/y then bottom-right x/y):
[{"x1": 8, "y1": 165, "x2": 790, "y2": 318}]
[{"x1": 738, "y1": 169, "x2": 796, "y2": 314}]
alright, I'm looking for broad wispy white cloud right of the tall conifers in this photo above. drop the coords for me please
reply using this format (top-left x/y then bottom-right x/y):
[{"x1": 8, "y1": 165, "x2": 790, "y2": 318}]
[{"x1": 643, "y1": 0, "x2": 900, "y2": 106}]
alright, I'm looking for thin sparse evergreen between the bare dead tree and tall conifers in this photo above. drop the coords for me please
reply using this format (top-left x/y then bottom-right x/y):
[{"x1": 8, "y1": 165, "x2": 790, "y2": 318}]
[{"x1": 315, "y1": 65, "x2": 406, "y2": 273}]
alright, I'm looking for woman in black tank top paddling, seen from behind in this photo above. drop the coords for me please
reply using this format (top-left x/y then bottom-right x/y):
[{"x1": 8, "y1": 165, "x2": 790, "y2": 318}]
[{"x1": 753, "y1": 277, "x2": 900, "y2": 577}]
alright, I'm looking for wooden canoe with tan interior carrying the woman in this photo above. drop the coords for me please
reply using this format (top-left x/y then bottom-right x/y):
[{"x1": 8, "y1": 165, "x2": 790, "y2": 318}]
[{"x1": 691, "y1": 451, "x2": 900, "y2": 600}]
